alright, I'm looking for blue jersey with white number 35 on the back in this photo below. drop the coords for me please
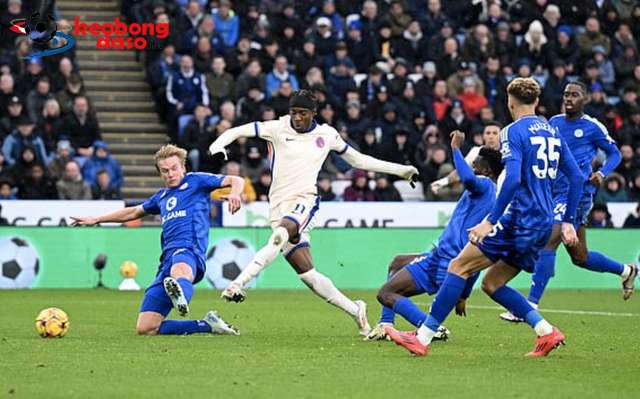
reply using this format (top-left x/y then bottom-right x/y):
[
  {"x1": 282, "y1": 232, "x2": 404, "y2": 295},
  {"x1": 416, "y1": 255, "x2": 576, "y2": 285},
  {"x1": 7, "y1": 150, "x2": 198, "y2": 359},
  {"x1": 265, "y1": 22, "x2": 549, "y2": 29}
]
[{"x1": 496, "y1": 115, "x2": 564, "y2": 230}]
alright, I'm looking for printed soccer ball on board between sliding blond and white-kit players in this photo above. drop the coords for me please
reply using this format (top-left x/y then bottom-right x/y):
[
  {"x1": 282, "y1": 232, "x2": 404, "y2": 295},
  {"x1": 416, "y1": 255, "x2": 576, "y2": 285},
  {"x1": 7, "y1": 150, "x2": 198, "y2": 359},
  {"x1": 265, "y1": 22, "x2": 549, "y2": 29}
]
[{"x1": 207, "y1": 238, "x2": 256, "y2": 290}]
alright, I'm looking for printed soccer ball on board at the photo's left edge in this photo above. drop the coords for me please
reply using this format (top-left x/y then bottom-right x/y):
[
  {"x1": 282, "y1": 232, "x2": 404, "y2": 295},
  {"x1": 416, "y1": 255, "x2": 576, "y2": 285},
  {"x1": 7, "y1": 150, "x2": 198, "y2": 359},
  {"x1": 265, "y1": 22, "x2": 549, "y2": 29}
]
[{"x1": 0, "y1": 237, "x2": 40, "y2": 288}]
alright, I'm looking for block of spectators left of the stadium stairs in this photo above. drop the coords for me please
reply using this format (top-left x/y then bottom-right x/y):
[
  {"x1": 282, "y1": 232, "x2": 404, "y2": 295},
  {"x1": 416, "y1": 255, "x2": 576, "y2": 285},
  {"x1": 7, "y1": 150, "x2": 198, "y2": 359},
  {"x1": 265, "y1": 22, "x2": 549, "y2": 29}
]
[{"x1": 0, "y1": 0, "x2": 123, "y2": 200}]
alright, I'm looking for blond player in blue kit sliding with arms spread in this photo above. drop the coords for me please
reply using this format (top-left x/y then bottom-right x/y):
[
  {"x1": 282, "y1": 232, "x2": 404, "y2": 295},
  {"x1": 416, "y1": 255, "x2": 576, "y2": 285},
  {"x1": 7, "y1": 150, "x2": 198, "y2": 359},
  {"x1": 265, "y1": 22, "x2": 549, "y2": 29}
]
[{"x1": 72, "y1": 145, "x2": 244, "y2": 335}]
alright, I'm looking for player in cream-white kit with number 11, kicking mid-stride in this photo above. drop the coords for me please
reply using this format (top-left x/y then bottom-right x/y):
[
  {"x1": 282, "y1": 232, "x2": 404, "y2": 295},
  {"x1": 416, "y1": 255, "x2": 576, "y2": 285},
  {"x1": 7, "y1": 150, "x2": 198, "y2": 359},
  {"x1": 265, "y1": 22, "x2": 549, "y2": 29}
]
[{"x1": 209, "y1": 90, "x2": 418, "y2": 335}]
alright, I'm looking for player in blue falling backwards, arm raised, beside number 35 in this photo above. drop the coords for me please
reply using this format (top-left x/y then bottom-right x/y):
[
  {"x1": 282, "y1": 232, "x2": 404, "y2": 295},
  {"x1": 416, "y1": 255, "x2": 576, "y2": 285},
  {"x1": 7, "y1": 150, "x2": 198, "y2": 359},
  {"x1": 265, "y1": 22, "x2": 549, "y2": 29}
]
[{"x1": 366, "y1": 131, "x2": 502, "y2": 340}]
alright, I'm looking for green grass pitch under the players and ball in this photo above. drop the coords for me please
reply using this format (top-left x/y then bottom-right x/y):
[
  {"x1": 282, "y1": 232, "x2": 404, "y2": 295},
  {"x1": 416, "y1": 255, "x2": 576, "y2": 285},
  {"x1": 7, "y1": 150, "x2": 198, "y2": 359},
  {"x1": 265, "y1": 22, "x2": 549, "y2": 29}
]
[{"x1": 0, "y1": 290, "x2": 640, "y2": 399}]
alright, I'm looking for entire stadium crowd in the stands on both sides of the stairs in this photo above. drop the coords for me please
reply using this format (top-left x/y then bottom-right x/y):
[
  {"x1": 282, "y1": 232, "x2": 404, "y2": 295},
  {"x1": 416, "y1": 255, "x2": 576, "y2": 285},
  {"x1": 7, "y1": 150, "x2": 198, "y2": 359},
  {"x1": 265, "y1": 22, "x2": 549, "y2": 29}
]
[{"x1": 0, "y1": 0, "x2": 640, "y2": 227}]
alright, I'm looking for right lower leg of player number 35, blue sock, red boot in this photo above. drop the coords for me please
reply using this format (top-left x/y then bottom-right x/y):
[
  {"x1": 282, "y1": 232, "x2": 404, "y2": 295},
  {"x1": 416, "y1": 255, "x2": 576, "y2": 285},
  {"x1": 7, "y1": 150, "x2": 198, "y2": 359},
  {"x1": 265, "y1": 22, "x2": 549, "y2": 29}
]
[{"x1": 482, "y1": 261, "x2": 565, "y2": 357}]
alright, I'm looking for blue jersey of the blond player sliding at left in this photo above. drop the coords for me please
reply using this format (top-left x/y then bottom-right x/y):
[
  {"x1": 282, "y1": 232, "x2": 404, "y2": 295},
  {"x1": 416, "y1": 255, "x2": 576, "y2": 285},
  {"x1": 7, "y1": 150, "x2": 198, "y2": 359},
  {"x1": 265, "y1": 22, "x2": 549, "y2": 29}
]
[{"x1": 142, "y1": 173, "x2": 224, "y2": 259}]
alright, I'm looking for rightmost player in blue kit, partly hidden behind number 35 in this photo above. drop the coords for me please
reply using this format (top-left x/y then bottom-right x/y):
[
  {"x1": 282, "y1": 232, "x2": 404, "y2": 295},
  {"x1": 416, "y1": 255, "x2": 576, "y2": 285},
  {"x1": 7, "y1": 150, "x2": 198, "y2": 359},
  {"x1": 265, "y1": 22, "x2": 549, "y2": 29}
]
[{"x1": 500, "y1": 82, "x2": 638, "y2": 322}]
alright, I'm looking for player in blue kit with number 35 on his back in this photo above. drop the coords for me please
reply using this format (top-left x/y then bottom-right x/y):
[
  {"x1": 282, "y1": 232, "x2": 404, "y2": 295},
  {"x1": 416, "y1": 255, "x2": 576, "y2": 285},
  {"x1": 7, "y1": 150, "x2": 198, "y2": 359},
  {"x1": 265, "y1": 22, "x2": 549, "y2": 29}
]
[{"x1": 387, "y1": 78, "x2": 585, "y2": 357}]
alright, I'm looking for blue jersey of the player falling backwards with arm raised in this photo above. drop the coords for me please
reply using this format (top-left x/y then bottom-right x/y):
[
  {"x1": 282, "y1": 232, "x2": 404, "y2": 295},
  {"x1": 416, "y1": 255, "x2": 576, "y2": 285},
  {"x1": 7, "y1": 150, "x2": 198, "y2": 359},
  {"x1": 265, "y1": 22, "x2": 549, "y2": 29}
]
[{"x1": 436, "y1": 176, "x2": 497, "y2": 259}]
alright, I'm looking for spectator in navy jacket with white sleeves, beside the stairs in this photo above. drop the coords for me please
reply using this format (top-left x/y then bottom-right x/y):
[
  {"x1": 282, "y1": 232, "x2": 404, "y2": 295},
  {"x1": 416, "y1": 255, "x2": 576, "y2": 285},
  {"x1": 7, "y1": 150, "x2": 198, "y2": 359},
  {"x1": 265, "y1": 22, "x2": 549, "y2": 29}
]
[{"x1": 167, "y1": 55, "x2": 209, "y2": 128}]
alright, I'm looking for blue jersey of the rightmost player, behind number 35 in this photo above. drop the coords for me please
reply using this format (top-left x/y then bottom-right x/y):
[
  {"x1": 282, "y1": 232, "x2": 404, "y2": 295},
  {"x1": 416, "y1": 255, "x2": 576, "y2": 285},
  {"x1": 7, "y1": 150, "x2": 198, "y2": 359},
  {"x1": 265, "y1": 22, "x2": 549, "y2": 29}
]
[{"x1": 549, "y1": 114, "x2": 616, "y2": 194}]
